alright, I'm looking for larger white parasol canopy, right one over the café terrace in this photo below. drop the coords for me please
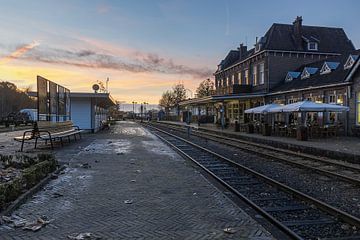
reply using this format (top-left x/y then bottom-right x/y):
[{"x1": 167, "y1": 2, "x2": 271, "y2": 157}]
[{"x1": 269, "y1": 101, "x2": 349, "y2": 113}]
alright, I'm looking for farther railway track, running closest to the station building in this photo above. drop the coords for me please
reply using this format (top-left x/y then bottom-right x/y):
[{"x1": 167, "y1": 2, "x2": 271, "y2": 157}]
[{"x1": 155, "y1": 124, "x2": 360, "y2": 186}]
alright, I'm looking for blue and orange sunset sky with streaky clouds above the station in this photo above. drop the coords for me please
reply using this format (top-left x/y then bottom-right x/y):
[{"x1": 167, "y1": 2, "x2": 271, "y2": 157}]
[{"x1": 0, "y1": 0, "x2": 360, "y2": 103}]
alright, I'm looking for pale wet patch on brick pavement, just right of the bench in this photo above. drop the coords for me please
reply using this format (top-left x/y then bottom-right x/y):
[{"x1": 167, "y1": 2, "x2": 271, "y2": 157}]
[{"x1": 80, "y1": 139, "x2": 131, "y2": 154}]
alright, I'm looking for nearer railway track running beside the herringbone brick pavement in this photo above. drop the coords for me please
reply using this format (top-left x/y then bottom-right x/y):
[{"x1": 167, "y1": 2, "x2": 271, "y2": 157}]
[{"x1": 148, "y1": 126, "x2": 360, "y2": 239}]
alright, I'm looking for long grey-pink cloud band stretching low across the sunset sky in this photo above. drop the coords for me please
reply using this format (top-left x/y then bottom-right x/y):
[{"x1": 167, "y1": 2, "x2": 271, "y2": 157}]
[{"x1": 11, "y1": 41, "x2": 212, "y2": 78}]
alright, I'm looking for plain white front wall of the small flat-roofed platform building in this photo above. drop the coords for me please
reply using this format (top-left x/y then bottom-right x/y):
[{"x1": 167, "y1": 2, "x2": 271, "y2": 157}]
[{"x1": 71, "y1": 98, "x2": 92, "y2": 130}]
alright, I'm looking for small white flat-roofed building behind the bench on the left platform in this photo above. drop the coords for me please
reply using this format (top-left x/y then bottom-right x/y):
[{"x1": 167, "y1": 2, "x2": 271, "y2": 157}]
[{"x1": 70, "y1": 92, "x2": 116, "y2": 132}]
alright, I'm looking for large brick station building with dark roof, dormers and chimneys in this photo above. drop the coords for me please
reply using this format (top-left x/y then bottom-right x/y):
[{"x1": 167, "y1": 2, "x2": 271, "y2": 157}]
[{"x1": 180, "y1": 17, "x2": 360, "y2": 135}]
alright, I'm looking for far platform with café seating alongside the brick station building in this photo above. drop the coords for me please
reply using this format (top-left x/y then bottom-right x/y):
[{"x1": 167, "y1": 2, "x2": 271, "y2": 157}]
[{"x1": 161, "y1": 121, "x2": 360, "y2": 163}]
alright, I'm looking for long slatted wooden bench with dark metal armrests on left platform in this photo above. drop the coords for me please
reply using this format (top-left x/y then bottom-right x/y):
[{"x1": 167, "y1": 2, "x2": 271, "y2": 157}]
[{"x1": 14, "y1": 121, "x2": 83, "y2": 151}]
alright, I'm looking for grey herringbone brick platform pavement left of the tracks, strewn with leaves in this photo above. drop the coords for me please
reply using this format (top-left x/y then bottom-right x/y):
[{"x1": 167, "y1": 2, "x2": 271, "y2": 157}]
[{"x1": 0, "y1": 122, "x2": 273, "y2": 240}]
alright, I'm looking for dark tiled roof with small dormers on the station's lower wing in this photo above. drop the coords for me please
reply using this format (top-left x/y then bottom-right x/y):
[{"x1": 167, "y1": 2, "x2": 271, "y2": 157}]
[{"x1": 271, "y1": 49, "x2": 360, "y2": 93}]
